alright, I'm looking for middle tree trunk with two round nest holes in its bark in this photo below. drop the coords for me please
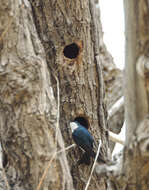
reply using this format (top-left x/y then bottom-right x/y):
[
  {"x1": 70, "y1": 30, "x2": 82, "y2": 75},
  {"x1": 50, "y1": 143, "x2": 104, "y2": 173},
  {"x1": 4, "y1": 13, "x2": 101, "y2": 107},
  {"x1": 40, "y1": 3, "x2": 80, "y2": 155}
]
[{"x1": 28, "y1": 0, "x2": 107, "y2": 189}]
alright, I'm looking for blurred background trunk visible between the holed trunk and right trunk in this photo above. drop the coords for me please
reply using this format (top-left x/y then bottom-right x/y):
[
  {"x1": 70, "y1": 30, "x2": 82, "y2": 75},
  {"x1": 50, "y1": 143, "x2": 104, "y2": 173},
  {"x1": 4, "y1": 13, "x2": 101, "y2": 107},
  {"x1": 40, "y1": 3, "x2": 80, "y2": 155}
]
[{"x1": 101, "y1": 49, "x2": 124, "y2": 150}]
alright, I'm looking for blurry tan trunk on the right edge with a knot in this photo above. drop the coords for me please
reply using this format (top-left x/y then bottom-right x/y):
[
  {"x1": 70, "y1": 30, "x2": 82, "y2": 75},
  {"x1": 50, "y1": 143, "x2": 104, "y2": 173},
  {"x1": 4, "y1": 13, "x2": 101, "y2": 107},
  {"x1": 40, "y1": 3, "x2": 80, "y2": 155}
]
[{"x1": 97, "y1": 0, "x2": 149, "y2": 190}]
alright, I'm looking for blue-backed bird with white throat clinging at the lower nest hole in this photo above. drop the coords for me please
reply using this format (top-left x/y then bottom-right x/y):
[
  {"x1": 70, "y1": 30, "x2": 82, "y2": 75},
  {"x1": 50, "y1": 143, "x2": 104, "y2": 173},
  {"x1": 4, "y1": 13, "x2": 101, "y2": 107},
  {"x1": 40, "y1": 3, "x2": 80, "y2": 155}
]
[{"x1": 70, "y1": 121, "x2": 105, "y2": 165}]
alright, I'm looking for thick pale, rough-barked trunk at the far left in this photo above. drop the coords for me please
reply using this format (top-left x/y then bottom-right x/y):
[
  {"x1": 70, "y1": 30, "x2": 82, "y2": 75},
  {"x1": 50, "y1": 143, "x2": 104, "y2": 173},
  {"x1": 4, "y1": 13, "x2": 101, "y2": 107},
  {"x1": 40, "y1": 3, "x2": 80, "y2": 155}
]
[{"x1": 0, "y1": 1, "x2": 72, "y2": 190}]
